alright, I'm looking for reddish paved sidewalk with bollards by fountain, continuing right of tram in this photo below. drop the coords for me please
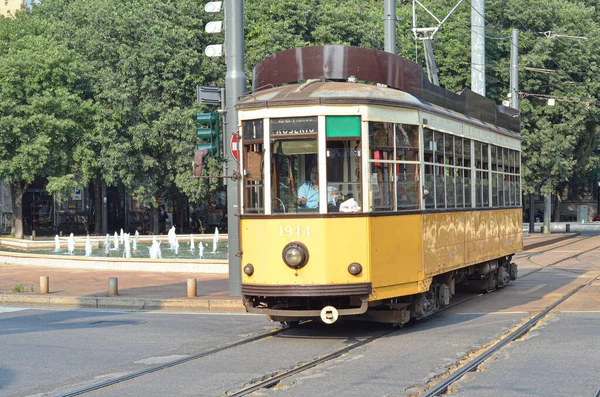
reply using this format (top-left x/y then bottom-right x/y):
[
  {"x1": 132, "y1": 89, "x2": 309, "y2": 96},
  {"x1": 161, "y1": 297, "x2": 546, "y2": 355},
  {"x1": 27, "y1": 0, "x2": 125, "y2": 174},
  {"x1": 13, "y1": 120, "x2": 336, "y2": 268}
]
[{"x1": 0, "y1": 233, "x2": 578, "y2": 312}]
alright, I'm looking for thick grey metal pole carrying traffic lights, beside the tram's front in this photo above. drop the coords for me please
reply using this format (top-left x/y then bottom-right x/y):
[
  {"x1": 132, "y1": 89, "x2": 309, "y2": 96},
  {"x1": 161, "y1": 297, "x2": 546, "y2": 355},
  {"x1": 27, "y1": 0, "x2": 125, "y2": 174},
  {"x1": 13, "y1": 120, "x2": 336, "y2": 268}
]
[{"x1": 223, "y1": 0, "x2": 246, "y2": 296}]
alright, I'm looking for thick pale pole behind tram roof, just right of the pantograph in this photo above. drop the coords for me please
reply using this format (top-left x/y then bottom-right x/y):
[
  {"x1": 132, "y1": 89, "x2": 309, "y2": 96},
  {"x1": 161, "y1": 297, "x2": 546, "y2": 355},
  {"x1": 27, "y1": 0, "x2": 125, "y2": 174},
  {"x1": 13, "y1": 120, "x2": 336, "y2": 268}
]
[{"x1": 471, "y1": 0, "x2": 485, "y2": 96}]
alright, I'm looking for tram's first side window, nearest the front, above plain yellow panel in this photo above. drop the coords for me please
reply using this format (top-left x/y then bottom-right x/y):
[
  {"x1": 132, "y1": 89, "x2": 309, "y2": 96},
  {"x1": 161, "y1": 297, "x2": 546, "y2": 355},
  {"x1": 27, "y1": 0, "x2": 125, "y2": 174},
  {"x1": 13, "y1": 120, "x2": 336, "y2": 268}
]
[{"x1": 368, "y1": 121, "x2": 421, "y2": 212}]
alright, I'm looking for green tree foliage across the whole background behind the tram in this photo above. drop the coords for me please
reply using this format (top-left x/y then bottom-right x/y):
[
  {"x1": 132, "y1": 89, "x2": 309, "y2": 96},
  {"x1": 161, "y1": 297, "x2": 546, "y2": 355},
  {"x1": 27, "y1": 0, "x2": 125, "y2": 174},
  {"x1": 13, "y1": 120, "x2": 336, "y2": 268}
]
[{"x1": 0, "y1": 0, "x2": 600, "y2": 213}]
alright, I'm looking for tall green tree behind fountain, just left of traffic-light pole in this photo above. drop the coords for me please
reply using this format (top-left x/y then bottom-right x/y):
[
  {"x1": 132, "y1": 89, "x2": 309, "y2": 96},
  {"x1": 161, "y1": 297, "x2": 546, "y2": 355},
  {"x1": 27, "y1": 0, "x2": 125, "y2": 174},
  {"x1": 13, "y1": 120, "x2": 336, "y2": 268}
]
[{"x1": 34, "y1": 0, "x2": 224, "y2": 232}]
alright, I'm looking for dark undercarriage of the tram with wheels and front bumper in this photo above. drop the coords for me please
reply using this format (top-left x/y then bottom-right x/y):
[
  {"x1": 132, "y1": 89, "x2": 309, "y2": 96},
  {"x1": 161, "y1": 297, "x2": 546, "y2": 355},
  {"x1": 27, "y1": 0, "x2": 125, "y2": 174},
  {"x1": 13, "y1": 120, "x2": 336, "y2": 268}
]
[{"x1": 244, "y1": 255, "x2": 517, "y2": 325}]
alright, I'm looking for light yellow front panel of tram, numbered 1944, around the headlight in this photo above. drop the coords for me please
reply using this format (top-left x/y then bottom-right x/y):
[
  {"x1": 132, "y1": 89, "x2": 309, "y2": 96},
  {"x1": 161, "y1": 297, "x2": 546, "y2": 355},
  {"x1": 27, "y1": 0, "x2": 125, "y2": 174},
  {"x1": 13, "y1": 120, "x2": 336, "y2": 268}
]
[{"x1": 241, "y1": 217, "x2": 370, "y2": 285}]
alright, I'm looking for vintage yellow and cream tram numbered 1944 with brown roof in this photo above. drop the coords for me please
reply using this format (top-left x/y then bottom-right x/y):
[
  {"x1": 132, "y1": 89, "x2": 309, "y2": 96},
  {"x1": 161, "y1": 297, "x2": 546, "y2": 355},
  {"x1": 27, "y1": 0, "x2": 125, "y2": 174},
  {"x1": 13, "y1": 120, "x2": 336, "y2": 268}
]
[{"x1": 238, "y1": 46, "x2": 523, "y2": 323}]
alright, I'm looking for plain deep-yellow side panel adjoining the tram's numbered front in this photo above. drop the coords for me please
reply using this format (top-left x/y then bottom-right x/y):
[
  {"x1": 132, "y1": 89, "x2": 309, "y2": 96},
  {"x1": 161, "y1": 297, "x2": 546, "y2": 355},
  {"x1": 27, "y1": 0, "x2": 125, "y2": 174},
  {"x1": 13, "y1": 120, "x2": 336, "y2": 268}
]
[{"x1": 367, "y1": 214, "x2": 429, "y2": 300}]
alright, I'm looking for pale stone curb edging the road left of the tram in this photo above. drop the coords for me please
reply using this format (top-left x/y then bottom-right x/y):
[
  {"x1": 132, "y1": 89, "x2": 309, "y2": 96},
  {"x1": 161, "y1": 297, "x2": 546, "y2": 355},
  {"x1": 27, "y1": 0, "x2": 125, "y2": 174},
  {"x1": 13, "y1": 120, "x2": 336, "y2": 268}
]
[{"x1": 0, "y1": 294, "x2": 246, "y2": 313}]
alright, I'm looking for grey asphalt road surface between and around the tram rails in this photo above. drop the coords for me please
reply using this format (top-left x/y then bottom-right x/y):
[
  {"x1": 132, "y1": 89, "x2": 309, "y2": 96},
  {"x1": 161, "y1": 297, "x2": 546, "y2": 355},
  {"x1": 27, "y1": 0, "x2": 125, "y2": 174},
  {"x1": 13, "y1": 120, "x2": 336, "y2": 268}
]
[{"x1": 0, "y1": 237, "x2": 600, "y2": 397}]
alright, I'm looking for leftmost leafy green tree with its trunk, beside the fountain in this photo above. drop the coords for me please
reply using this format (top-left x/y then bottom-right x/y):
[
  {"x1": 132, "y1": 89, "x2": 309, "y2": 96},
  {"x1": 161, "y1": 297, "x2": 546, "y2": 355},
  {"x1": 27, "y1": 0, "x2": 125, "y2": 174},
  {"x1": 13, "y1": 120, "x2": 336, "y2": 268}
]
[{"x1": 0, "y1": 12, "x2": 93, "y2": 238}]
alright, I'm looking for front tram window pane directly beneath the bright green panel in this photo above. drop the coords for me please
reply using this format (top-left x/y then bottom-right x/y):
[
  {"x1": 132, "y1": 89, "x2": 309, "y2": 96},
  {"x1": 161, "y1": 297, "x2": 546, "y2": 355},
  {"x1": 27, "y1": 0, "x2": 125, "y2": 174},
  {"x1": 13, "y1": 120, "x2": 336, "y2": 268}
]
[{"x1": 327, "y1": 140, "x2": 362, "y2": 212}]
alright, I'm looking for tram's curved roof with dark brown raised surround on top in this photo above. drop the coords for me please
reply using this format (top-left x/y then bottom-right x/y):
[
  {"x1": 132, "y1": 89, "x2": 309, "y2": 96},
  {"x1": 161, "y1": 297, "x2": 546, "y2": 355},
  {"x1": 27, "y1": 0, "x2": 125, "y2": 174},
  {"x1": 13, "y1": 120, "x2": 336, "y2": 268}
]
[{"x1": 238, "y1": 46, "x2": 520, "y2": 134}]
